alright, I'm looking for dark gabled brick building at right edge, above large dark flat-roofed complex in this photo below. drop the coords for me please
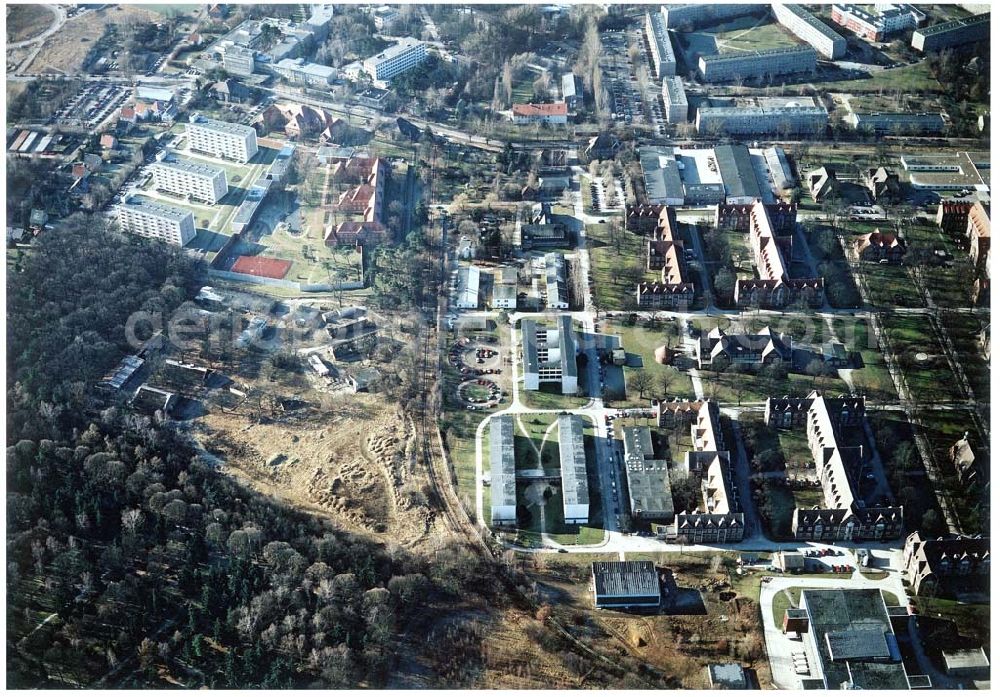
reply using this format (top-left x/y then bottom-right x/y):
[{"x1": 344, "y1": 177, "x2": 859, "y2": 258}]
[{"x1": 903, "y1": 532, "x2": 991, "y2": 595}]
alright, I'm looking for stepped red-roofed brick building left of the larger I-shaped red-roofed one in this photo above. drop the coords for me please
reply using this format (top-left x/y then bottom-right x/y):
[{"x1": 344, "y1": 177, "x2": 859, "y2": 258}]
[{"x1": 636, "y1": 206, "x2": 694, "y2": 310}]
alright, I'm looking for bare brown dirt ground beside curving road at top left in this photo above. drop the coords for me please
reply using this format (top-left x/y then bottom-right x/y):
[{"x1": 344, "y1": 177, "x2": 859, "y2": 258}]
[{"x1": 23, "y1": 5, "x2": 159, "y2": 75}]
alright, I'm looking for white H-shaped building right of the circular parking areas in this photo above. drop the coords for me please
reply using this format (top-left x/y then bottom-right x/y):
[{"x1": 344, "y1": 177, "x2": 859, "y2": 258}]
[{"x1": 521, "y1": 315, "x2": 578, "y2": 394}]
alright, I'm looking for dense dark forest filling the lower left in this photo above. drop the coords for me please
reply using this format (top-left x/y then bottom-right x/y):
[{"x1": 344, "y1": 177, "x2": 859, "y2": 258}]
[{"x1": 7, "y1": 217, "x2": 501, "y2": 688}]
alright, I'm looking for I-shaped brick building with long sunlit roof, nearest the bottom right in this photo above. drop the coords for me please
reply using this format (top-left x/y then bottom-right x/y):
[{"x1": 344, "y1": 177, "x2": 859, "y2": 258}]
[{"x1": 764, "y1": 391, "x2": 903, "y2": 541}]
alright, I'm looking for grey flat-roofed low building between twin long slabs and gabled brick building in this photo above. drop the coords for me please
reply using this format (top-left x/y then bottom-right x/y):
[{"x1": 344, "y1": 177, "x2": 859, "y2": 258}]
[{"x1": 622, "y1": 426, "x2": 674, "y2": 521}]
